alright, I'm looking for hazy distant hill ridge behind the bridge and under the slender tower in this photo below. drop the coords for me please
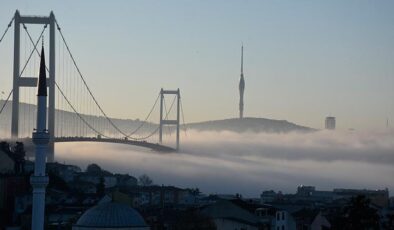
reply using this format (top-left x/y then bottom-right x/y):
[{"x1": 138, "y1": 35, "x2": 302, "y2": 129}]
[{"x1": 0, "y1": 100, "x2": 314, "y2": 136}]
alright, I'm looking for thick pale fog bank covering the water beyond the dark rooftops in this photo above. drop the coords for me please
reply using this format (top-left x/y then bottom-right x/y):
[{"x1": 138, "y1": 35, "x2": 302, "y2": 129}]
[{"x1": 56, "y1": 130, "x2": 394, "y2": 197}]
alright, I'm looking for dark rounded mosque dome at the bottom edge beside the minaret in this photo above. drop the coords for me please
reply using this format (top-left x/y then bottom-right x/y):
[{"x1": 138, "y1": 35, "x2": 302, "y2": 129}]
[{"x1": 73, "y1": 202, "x2": 149, "y2": 230}]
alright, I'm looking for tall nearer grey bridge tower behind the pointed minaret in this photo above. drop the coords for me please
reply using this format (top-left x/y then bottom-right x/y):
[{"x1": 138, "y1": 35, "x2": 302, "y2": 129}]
[{"x1": 11, "y1": 10, "x2": 55, "y2": 162}]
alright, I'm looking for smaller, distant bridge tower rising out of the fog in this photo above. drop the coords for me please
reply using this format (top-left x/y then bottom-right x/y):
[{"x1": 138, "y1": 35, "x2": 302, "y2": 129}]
[{"x1": 159, "y1": 88, "x2": 181, "y2": 151}]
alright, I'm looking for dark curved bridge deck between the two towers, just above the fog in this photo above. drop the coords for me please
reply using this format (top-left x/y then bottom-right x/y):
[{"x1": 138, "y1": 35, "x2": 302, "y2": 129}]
[{"x1": 55, "y1": 137, "x2": 176, "y2": 152}]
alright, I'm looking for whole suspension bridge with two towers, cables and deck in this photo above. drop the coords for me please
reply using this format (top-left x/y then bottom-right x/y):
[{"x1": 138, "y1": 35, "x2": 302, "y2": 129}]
[{"x1": 0, "y1": 11, "x2": 186, "y2": 162}]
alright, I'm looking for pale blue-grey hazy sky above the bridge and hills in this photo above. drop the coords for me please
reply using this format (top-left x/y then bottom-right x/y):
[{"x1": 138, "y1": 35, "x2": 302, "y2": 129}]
[{"x1": 0, "y1": 0, "x2": 394, "y2": 129}]
